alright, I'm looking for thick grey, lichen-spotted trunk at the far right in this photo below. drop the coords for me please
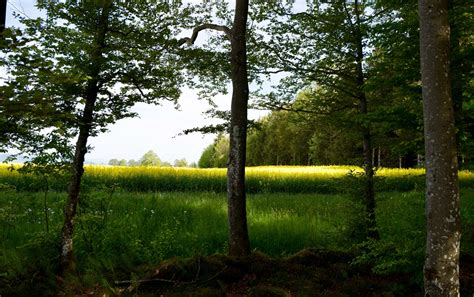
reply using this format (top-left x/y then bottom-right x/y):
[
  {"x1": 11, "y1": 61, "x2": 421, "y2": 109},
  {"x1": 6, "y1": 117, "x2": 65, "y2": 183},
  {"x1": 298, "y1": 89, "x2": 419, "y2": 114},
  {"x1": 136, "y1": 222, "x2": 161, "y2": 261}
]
[{"x1": 419, "y1": 0, "x2": 461, "y2": 297}]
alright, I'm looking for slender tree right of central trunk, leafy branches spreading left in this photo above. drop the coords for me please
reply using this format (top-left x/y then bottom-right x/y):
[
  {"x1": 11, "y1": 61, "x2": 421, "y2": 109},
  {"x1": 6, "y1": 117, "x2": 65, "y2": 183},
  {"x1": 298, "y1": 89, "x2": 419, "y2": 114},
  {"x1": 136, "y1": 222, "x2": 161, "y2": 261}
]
[{"x1": 256, "y1": 0, "x2": 380, "y2": 238}]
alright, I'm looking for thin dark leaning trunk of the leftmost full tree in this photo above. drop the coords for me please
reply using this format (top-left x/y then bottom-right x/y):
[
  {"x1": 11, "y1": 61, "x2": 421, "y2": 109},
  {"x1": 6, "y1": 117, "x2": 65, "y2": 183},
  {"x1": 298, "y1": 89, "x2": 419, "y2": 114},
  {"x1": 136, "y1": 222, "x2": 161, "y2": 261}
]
[{"x1": 58, "y1": 4, "x2": 109, "y2": 281}]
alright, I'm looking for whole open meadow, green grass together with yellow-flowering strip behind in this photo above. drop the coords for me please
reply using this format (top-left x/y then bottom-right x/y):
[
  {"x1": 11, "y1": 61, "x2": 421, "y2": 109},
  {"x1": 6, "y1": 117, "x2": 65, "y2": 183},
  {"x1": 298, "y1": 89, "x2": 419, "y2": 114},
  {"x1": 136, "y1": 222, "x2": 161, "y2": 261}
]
[{"x1": 0, "y1": 166, "x2": 474, "y2": 296}]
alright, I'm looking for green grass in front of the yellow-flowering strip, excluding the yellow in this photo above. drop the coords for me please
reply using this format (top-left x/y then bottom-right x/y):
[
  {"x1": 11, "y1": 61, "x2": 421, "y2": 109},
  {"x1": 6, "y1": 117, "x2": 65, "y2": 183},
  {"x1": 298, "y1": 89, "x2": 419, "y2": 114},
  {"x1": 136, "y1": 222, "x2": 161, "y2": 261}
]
[{"x1": 0, "y1": 189, "x2": 474, "y2": 292}]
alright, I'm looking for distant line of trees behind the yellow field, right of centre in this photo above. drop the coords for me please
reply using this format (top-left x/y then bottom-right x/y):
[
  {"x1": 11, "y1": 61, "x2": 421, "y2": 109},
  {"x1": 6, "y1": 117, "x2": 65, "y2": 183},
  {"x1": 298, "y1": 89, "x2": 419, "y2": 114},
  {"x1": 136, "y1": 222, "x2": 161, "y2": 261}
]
[{"x1": 198, "y1": 92, "x2": 474, "y2": 169}]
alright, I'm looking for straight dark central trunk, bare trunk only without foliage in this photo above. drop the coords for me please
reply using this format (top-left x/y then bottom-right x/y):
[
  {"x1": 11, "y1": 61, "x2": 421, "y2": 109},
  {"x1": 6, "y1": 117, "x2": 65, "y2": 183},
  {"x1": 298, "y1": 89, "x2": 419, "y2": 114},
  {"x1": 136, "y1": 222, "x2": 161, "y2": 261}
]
[{"x1": 227, "y1": 0, "x2": 250, "y2": 257}]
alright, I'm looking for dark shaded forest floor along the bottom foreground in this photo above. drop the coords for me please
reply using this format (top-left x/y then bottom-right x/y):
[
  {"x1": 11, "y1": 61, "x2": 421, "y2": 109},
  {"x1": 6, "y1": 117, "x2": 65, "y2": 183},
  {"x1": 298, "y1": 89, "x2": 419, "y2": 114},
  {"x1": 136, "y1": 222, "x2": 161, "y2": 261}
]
[{"x1": 68, "y1": 249, "x2": 474, "y2": 297}]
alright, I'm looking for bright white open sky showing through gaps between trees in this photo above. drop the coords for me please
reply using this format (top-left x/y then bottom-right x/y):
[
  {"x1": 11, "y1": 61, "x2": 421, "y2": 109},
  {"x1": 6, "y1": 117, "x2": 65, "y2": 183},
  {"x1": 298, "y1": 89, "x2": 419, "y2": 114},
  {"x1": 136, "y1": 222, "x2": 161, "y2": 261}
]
[{"x1": 6, "y1": 0, "x2": 266, "y2": 164}]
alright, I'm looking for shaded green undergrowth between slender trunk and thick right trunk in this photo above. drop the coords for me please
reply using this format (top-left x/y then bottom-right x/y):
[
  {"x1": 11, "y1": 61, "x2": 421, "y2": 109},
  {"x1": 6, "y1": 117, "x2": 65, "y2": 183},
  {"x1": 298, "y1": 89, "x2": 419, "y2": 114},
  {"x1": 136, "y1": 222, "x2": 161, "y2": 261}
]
[{"x1": 353, "y1": 190, "x2": 430, "y2": 285}]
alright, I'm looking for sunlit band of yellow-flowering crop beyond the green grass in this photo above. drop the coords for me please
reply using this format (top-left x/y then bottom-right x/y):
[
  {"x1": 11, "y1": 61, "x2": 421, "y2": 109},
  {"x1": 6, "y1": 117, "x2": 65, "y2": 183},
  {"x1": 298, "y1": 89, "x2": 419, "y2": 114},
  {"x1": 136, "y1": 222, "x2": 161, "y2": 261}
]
[{"x1": 0, "y1": 165, "x2": 474, "y2": 194}]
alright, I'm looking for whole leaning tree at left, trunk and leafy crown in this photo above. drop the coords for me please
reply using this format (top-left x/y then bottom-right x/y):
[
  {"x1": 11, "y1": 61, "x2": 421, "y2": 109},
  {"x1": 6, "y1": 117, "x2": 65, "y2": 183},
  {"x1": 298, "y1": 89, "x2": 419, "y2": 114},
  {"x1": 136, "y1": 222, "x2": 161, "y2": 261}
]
[{"x1": 0, "y1": 0, "x2": 180, "y2": 279}]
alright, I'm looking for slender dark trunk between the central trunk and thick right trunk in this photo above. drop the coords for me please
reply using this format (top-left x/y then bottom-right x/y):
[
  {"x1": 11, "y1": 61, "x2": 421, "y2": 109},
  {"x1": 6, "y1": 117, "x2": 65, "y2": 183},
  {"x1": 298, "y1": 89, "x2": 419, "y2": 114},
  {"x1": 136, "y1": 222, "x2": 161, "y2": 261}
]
[{"x1": 354, "y1": 0, "x2": 379, "y2": 239}]
